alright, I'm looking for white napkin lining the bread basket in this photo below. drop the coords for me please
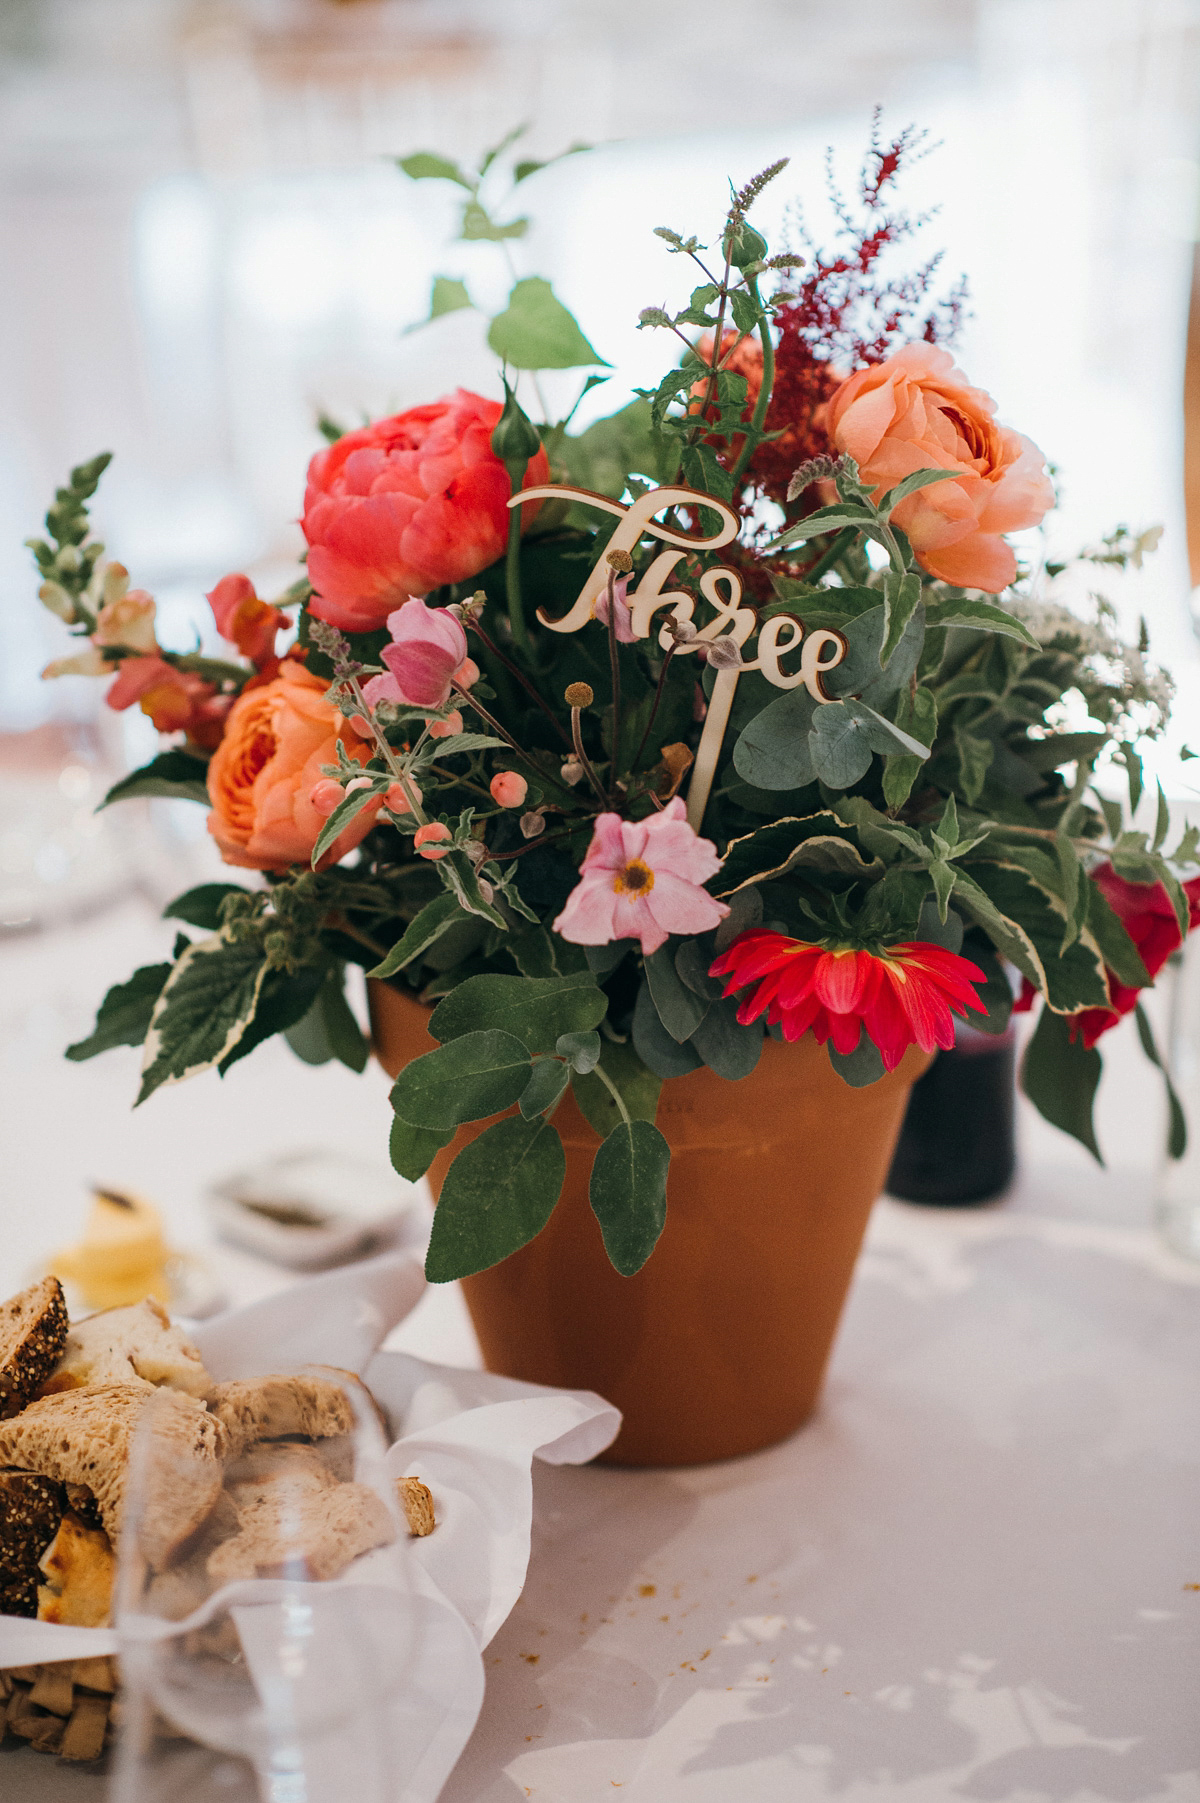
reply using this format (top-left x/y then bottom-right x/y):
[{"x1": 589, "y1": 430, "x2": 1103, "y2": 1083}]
[{"x1": 0, "y1": 1249, "x2": 620, "y2": 1803}]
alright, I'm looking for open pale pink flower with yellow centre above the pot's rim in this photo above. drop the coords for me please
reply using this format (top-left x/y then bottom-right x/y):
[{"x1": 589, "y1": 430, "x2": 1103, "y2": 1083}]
[{"x1": 553, "y1": 797, "x2": 730, "y2": 952}]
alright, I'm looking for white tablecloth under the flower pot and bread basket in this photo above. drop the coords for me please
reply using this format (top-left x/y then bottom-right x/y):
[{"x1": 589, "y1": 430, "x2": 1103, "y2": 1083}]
[{"x1": 0, "y1": 903, "x2": 1200, "y2": 1803}]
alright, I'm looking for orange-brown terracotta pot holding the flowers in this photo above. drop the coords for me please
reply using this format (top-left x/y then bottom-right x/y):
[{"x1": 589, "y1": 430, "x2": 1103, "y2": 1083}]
[{"x1": 369, "y1": 983, "x2": 930, "y2": 1466}]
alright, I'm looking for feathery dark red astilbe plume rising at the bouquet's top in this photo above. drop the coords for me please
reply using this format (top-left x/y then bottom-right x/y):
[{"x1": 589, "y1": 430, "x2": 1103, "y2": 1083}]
[{"x1": 750, "y1": 108, "x2": 966, "y2": 512}]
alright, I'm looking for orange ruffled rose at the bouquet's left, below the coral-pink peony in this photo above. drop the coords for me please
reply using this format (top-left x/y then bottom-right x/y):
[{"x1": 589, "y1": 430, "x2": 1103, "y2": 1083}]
[{"x1": 209, "y1": 658, "x2": 378, "y2": 871}]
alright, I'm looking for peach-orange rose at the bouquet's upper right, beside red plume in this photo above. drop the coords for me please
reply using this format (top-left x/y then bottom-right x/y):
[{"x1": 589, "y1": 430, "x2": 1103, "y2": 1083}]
[{"x1": 829, "y1": 344, "x2": 1054, "y2": 595}]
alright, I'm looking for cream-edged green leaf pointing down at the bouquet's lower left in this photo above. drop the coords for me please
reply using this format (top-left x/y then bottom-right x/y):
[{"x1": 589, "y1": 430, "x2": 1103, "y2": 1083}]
[{"x1": 135, "y1": 934, "x2": 267, "y2": 1105}]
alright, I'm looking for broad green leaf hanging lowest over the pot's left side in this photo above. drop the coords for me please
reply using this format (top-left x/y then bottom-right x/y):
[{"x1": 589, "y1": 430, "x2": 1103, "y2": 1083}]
[{"x1": 425, "y1": 1114, "x2": 566, "y2": 1284}]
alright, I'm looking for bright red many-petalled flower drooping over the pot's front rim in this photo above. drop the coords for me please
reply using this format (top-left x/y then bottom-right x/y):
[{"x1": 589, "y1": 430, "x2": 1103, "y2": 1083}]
[{"x1": 710, "y1": 927, "x2": 987, "y2": 1071}]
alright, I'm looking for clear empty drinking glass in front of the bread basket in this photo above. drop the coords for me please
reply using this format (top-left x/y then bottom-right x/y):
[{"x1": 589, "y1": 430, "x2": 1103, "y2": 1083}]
[{"x1": 112, "y1": 1367, "x2": 410, "y2": 1803}]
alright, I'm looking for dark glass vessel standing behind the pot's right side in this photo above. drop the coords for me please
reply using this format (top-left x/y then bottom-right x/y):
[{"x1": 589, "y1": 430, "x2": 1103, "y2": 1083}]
[{"x1": 886, "y1": 1028, "x2": 1016, "y2": 1208}]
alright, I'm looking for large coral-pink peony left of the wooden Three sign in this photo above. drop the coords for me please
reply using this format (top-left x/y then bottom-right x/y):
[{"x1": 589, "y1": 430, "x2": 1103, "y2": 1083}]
[{"x1": 303, "y1": 388, "x2": 550, "y2": 633}]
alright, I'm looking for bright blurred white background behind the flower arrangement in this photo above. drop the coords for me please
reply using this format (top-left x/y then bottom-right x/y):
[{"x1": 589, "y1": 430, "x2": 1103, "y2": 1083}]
[{"x1": 0, "y1": 0, "x2": 1200, "y2": 1312}]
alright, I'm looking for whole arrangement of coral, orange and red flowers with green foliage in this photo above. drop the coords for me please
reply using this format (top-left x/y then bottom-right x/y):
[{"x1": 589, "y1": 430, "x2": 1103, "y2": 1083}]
[{"x1": 31, "y1": 123, "x2": 1200, "y2": 1280}]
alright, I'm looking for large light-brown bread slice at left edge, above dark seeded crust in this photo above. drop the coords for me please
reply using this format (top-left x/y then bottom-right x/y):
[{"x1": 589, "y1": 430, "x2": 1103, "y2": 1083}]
[{"x1": 0, "y1": 1383, "x2": 227, "y2": 1570}]
